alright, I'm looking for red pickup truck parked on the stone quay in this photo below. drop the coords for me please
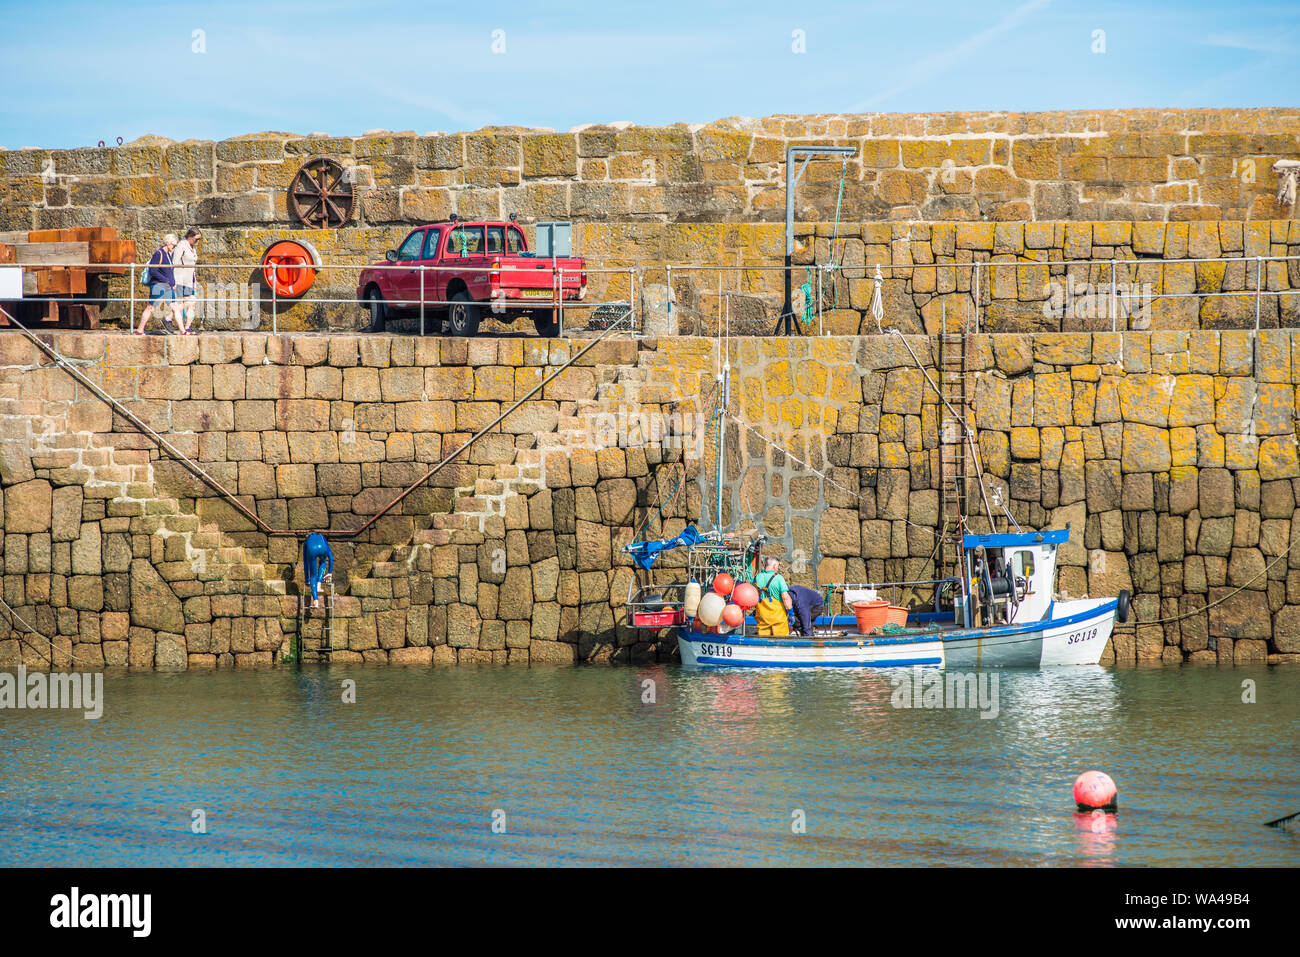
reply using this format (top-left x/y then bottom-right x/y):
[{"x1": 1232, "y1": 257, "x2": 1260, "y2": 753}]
[{"x1": 356, "y1": 217, "x2": 586, "y2": 335}]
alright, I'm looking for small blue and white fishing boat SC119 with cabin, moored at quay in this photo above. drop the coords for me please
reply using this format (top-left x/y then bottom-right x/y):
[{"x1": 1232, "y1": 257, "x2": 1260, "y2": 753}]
[{"x1": 628, "y1": 527, "x2": 1130, "y2": 668}]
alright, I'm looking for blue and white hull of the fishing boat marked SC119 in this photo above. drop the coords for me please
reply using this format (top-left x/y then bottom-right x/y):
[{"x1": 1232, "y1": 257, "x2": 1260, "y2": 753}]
[{"x1": 677, "y1": 598, "x2": 1118, "y2": 668}]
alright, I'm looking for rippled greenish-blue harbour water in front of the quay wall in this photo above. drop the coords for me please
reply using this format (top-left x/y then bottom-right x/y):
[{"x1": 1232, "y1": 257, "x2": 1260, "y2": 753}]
[{"x1": 0, "y1": 667, "x2": 1300, "y2": 866}]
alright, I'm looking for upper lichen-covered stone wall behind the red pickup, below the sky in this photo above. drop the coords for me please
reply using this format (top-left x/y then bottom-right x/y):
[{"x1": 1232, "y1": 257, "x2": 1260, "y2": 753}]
[{"x1": 0, "y1": 109, "x2": 1300, "y2": 334}]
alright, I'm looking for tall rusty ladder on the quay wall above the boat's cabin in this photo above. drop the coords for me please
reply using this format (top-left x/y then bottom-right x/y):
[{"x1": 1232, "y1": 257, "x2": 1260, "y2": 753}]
[{"x1": 937, "y1": 322, "x2": 972, "y2": 577}]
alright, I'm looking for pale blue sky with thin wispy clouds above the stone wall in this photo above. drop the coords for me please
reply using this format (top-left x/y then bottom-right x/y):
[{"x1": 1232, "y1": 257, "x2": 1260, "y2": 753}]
[{"x1": 0, "y1": 0, "x2": 1300, "y2": 148}]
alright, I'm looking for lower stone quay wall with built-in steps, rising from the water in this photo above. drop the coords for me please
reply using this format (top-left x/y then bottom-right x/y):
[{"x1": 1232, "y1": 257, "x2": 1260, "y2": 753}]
[{"x1": 0, "y1": 330, "x2": 1300, "y2": 670}]
